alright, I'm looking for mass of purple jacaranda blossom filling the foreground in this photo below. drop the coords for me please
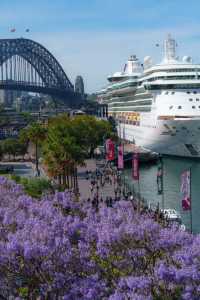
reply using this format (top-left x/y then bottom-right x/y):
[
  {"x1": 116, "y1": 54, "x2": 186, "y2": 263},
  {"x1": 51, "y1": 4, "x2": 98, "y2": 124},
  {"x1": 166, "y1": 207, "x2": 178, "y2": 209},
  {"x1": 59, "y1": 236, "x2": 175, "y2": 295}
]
[{"x1": 0, "y1": 177, "x2": 200, "y2": 300}]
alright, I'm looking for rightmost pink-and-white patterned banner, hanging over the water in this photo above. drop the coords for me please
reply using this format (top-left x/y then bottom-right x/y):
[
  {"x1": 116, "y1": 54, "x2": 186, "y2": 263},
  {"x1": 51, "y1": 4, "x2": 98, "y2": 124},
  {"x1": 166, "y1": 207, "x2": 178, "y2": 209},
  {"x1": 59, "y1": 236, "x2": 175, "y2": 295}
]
[{"x1": 181, "y1": 170, "x2": 191, "y2": 210}]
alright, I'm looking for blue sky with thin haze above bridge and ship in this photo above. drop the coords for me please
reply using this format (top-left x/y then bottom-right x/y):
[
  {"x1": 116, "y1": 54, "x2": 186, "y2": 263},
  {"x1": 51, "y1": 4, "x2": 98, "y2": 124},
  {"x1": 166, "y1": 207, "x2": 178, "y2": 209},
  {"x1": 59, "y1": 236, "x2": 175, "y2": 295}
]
[{"x1": 0, "y1": 0, "x2": 200, "y2": 92}]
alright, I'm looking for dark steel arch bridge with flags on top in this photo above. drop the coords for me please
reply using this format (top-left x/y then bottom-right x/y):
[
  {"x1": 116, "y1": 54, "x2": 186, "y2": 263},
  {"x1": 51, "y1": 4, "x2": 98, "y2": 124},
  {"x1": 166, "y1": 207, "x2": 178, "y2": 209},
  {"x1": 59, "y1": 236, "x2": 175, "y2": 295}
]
[{"x1": 0, "y1": 38, "x2": 81, "y2": 106}]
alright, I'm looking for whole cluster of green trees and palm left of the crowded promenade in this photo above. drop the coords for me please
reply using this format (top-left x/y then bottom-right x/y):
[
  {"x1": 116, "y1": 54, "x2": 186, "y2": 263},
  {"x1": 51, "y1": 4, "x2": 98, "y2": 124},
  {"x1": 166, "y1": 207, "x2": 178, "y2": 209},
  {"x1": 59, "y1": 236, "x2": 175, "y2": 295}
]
[{"x1": 20, "y1": 114, "x2": 116, "y2": 189}]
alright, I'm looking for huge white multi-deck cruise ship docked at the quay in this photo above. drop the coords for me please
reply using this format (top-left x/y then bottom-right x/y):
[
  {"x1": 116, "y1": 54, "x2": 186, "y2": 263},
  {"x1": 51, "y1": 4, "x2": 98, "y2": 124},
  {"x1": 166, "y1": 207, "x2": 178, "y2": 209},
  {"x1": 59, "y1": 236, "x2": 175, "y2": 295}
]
[{"x1": 98, "y1": 35, "x2": 200, "y2": 157}]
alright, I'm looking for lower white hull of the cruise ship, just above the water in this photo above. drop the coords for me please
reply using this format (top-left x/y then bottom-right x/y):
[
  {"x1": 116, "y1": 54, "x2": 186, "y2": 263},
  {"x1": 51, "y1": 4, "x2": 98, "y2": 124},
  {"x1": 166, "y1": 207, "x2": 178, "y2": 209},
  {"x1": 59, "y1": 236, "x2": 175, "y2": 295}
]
[{"x1": 118, "y1": 119, "x2": 200, "y2": 157}]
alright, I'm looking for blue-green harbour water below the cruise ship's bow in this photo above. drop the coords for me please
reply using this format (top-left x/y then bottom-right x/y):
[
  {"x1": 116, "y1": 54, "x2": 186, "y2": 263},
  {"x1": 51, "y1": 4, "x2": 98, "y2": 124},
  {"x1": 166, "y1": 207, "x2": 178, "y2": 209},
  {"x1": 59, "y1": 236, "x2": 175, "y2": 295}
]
[{"x1": 125, "y1": 156, "x2": 200, "y2": 233}]
